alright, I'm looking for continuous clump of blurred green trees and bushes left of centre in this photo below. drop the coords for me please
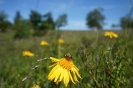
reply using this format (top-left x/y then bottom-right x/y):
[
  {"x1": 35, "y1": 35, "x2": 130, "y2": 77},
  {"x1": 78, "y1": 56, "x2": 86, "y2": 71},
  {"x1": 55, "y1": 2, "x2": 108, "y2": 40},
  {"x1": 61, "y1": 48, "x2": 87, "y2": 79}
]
[{"x1": 0, "y1": 10, "x2": 67, "y2": 38}]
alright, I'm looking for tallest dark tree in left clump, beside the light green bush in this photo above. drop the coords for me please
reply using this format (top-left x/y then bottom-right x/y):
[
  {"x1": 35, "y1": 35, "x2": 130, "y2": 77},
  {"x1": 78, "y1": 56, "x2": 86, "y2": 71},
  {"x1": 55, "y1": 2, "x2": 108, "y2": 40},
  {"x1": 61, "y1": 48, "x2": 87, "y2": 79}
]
[{"x1": 30, "y1": 10, "x2": 42, "y2": 29}]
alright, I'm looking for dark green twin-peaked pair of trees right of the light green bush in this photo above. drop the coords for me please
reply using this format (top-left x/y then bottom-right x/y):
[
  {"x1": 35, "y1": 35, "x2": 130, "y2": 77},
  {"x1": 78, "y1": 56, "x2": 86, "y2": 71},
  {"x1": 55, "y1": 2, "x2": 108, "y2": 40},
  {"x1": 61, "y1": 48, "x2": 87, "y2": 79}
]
[{"x1": 30, "y1": 10, "x2": 55, "y2": 36}]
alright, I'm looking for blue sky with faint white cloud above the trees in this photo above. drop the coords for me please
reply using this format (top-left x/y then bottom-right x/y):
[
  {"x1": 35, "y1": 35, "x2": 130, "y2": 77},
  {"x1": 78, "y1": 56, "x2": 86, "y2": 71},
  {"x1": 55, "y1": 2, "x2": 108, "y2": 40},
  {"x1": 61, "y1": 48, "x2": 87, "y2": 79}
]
[{"x1": 0, "y1": 0, "x2": 133, "y2": 30}]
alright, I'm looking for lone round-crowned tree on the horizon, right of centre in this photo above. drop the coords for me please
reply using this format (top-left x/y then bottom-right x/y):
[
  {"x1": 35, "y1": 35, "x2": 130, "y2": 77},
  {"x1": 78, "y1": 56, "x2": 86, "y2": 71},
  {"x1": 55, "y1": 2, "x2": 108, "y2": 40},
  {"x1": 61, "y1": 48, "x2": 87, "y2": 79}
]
[{"x1": 86, "y1": 8, "x2": 105, "y2": 29}]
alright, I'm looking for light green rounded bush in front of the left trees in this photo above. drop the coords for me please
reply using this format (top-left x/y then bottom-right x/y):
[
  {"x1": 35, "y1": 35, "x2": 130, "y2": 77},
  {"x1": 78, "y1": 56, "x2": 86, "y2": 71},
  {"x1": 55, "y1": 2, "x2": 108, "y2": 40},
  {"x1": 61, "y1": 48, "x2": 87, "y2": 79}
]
[{"x1": 13, "y1": 20, "x2": 34, "y2": 39}]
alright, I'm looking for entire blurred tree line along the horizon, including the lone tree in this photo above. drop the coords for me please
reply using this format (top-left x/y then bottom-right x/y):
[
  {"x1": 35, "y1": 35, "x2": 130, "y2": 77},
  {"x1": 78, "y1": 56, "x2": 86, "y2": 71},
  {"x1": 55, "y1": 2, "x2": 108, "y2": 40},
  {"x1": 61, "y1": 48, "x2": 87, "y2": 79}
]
[{"x1": 0, "y1": 8, "x2": 133, "y2": 38}]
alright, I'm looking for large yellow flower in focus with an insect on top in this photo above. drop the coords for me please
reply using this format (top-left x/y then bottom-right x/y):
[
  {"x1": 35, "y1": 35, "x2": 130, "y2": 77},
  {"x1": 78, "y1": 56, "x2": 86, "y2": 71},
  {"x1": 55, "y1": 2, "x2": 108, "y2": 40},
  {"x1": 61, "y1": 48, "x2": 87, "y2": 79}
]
[{"x1": 48, "y1": 53, "x2": 81, "y2": 87}]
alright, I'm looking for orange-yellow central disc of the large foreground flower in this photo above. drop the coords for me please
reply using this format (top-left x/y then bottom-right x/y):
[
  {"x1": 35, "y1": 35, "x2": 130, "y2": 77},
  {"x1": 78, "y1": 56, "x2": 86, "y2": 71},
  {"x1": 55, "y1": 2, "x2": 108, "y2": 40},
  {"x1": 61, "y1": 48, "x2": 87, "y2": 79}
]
[{"x1": 59, "y1": 58, "x2": 73, "y2": 70}]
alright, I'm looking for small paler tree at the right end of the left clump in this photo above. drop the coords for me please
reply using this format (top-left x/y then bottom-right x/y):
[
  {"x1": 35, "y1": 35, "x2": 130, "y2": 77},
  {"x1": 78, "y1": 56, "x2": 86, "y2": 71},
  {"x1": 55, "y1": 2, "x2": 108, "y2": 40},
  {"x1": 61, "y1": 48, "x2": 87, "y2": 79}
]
[{"x1": 55, "y1": 14, "x2": 67, "y2": 29}]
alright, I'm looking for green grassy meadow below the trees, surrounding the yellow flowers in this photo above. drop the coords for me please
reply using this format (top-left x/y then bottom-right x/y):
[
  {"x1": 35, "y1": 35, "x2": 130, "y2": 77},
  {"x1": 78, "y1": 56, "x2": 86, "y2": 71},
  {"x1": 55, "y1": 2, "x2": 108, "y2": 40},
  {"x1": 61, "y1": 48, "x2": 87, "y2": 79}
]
[{"x1": 0, "y1": 30, "x2": 133, "y2": 88}]
